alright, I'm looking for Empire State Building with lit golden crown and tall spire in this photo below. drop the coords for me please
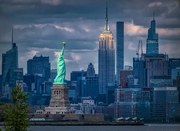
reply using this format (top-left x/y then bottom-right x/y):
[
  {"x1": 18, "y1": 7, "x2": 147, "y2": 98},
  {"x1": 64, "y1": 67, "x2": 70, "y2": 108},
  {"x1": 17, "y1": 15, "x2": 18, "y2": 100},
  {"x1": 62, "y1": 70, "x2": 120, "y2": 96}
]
[{"x1": 98, "y1": 4, "x2": 115, "y2": 94}]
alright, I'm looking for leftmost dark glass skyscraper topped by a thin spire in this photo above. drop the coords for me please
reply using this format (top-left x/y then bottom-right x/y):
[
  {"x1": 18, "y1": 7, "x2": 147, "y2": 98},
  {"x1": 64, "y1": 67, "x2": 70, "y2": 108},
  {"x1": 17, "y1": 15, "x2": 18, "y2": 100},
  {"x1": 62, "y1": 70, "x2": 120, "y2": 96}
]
[{"x1": 2, "y1": 29, "x2": 18, "y2": 95}]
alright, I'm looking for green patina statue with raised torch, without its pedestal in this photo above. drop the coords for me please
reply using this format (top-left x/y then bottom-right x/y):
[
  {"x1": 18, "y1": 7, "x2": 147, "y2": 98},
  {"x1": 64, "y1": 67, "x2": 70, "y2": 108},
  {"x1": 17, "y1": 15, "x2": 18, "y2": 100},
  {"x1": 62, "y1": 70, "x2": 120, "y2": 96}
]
[{"x1": 53, "y1": 42, "x2": 66, "y2": 84}]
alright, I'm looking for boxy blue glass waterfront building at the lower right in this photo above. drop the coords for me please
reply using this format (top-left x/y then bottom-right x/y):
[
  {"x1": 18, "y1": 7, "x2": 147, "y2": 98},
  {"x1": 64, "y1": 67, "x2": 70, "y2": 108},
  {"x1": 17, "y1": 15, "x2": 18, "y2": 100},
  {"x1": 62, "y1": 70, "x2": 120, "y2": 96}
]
[{"x1": 152, "y1": 87, "x2": 180, "y2": 122}]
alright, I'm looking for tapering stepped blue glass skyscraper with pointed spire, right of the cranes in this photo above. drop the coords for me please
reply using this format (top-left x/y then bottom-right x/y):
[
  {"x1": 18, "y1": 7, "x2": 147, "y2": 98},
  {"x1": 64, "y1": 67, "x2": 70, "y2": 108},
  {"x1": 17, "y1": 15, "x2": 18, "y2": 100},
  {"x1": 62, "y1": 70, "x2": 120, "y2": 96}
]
[{"x1": 146, "y1": 15, "x2": 159, "y2": 54}]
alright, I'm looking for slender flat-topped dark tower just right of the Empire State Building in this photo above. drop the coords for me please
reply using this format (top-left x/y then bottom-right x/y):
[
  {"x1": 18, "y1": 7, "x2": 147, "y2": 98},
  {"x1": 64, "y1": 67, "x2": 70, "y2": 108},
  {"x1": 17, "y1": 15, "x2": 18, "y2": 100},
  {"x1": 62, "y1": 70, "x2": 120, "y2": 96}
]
[{"x1": 116, "y1": 21, "x2": 124, "y2": 84}]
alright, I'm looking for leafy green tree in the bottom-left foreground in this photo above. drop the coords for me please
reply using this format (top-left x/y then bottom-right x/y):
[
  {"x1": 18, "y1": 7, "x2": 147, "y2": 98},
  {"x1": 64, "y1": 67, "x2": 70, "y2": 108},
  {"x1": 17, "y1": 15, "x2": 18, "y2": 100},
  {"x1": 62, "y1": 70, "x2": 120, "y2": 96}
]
[{"x1": 4, "y1": 84, "x2": 29, "y2": 131}]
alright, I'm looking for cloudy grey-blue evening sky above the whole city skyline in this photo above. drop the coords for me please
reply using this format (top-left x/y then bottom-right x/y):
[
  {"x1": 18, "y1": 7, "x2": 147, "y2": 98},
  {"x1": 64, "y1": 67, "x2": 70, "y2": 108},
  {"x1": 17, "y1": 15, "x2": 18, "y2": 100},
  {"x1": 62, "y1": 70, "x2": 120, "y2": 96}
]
[{"x1": 0, "y1": 0, "x2": 180, "y2": 78}]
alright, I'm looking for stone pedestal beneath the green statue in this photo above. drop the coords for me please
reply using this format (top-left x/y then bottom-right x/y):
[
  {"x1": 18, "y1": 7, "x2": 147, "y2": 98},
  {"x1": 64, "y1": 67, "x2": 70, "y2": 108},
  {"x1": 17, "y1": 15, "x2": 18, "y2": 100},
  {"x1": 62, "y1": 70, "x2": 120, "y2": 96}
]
[{"x1": 45, "y1": 84, "x2": 70, "y2": 114}]
